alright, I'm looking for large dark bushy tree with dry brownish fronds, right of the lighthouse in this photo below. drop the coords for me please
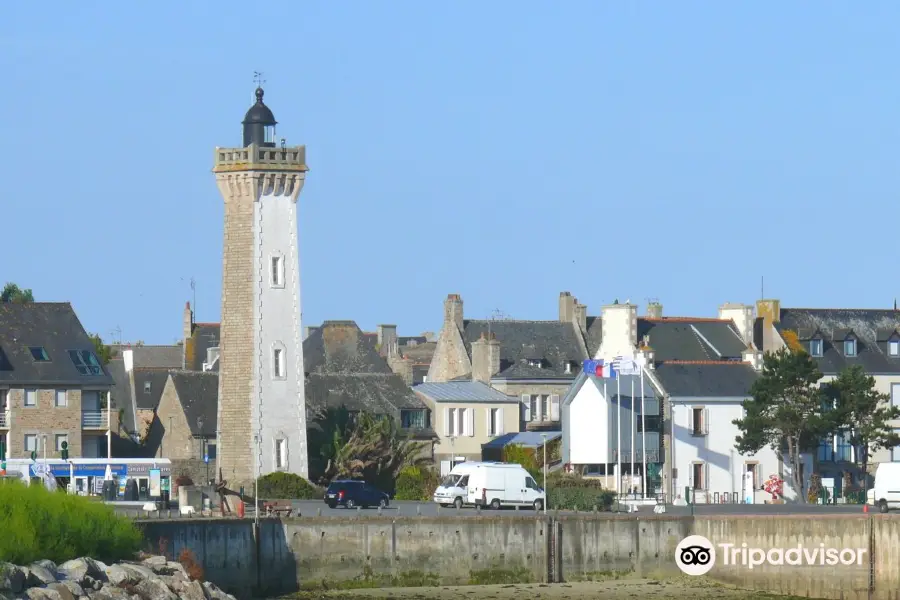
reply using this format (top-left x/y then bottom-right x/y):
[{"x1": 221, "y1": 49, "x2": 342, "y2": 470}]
[{"x1": 309, "y1": 407, "x2": 427, "y2": 493}]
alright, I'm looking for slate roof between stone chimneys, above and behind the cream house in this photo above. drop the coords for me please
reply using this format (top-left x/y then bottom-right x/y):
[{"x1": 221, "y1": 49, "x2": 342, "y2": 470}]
[{"x1": 462, "y1": 320, "x2": 588, "y2": 379}]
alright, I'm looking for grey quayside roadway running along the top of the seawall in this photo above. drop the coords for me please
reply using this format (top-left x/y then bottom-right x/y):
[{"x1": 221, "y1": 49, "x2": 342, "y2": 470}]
[{"x1": 116, "y1": 500, "x2": 873, "y2": 519}]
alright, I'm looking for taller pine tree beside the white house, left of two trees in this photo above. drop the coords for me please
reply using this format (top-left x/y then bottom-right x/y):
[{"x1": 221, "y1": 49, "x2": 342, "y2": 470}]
[{"x1": 734, "y1": 348, "x2": 834, "y2": 501}]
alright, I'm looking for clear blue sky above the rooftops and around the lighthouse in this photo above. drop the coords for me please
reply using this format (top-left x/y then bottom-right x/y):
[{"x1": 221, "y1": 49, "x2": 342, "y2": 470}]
[{"x1": 0, "y1": 0, "x2": 900, "y2": 343}]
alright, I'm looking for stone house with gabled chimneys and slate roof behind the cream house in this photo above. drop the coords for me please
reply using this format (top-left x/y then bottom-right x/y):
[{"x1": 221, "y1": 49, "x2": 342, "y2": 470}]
[{"x1": 427, "y1": 292, "x2": 600, "y2": 431}]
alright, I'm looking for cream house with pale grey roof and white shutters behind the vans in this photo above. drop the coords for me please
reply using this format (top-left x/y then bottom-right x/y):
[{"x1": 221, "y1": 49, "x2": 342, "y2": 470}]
[{"x1": 413, "y1": 381, "x2": 521, "y2": 475}]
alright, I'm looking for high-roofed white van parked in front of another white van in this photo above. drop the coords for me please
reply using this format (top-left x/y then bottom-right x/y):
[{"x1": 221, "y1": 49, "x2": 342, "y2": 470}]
[{"x1": 466, "y1": 463, "x2": 547, "y2": 510}]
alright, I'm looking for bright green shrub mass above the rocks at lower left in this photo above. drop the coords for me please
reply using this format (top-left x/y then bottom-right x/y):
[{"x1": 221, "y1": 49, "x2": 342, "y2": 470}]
[{"x1": 0, "y1": 481, "x2": 143, "y2": 565}]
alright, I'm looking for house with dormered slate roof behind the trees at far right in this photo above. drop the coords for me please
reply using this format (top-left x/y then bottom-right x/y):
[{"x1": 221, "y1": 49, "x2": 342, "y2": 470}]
[{"x1": 754, "y1": 299, "x2": 900, "y2": 495}]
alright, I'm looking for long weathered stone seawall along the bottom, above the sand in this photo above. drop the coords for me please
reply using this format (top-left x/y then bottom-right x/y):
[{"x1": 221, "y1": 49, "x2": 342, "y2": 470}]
[{"x1": 142, "y1": 514, "x2": 900, "y2": 600}]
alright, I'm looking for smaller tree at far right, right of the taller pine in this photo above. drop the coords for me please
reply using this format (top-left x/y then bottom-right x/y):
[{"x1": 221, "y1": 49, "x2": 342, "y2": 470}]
[{"x1": 827, "y1": 365, "x2": 900, "y2": 471}]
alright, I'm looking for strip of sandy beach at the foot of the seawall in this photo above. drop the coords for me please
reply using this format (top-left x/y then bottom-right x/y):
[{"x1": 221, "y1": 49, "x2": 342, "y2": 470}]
[{"x1": 292, "y1": 579, "x2": 808, "y2": 600}]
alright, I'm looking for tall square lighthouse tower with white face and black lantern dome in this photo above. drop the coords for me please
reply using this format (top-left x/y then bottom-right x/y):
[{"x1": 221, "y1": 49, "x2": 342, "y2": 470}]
[{"x1": 213, "y1": 87, "x2": 308, "y2": 490}]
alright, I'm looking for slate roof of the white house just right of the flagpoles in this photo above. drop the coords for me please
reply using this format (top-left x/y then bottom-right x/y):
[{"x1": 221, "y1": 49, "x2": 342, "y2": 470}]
[{"x1": 654, "y1": 361, "x2": 759, "y2": 398}]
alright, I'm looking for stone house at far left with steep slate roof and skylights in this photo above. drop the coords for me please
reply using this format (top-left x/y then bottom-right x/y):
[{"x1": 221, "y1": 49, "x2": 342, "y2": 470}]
[{"x1": 0, "y1": 302, "x2": 119, "y2": 458}]
